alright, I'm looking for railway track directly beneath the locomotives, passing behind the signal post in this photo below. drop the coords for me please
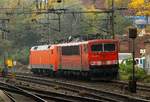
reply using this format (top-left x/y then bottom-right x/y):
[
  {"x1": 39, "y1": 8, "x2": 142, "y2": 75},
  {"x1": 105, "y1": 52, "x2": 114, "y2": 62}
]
[{"x1": 15, "y1": 73, "x2": 150, "y2": 95}]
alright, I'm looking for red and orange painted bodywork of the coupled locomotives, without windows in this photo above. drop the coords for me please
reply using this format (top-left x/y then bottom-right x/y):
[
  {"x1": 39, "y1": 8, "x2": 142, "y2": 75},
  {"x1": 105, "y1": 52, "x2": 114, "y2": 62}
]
[{"x1": 30, "y1": 40, "x2": 118, "y2": 71}]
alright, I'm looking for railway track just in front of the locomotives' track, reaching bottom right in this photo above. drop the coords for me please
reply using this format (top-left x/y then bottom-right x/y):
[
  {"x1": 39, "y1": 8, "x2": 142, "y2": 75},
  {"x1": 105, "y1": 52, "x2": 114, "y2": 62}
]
[{"x1": 13, "y1": 75, "x2": 149, "y2": 102}]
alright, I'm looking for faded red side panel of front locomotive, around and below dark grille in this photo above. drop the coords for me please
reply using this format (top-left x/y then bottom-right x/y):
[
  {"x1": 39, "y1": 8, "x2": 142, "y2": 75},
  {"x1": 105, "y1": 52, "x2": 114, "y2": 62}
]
[{"x1": 59, "y1": 44, "x2": 89, "y2": 71}]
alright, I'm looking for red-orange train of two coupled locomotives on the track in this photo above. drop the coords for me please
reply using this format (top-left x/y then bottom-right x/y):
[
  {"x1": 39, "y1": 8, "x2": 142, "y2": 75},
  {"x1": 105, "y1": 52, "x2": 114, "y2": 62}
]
[{"x1": 30, "y1": 39, "x2": 119, "y2": 79}]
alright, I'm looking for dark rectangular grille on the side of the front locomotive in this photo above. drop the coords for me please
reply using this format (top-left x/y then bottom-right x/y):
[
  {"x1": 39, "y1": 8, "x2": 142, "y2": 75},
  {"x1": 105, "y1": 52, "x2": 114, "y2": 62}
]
[{"x1": 62, "y1": 46, "x2": 80, "y2": 55}]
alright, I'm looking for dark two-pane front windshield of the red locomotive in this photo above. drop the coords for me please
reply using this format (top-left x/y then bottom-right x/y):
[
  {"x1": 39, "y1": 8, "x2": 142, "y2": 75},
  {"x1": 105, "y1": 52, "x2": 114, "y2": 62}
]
[{"x1": 91, "y1": 43, "x2": 115, "y2": 52}]
